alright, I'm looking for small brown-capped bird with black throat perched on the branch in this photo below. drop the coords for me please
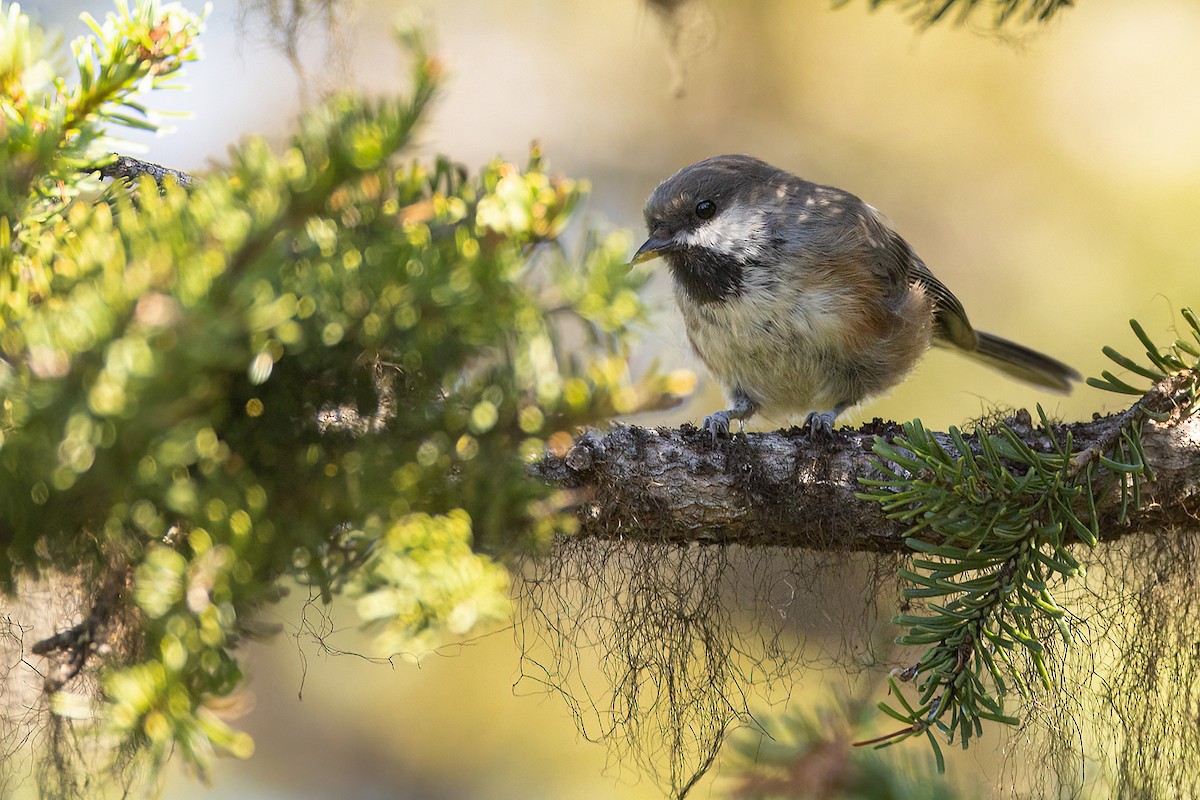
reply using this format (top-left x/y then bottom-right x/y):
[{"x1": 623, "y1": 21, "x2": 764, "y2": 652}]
[{"x1": 632, "y1": 156, "x2": 1079, "y2": 438}]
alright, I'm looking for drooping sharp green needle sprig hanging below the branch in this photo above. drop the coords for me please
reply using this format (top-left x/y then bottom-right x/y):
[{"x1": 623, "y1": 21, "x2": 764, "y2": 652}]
[{"x1": 863, "y1": 417, "x2": 1098, "y2": 758}]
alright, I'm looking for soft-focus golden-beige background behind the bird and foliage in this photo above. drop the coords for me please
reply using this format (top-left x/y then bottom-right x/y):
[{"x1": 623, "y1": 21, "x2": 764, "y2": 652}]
[{"x1": 22, "y1": 0, "x2": 1200, "y2": 800}]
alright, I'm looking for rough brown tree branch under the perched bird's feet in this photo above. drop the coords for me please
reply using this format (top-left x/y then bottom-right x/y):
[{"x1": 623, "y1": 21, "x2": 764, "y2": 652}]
[{"x1": 534, "y1": 379, "x2": 1200, "y2": 552}]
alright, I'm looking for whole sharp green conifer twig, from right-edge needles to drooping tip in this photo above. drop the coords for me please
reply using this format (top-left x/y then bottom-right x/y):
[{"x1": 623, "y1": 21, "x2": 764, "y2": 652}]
[{"x1": 860, "y1": 309, "x2": 1200, "y2": 763}]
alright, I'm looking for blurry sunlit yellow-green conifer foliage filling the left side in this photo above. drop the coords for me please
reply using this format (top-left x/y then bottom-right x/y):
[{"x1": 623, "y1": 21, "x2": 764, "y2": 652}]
[{"x1": 0, "y1": 0, "x2": 670, "y2": 786}]
